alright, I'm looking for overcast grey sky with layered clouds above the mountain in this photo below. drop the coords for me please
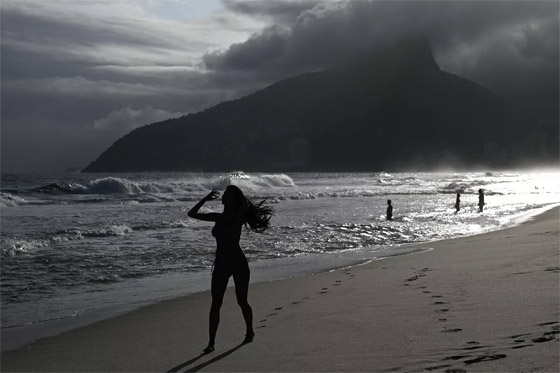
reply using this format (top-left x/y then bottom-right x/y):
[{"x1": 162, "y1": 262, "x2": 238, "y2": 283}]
[{"x1": 0, "y1": 0, "x2": 559, "y2": 173}]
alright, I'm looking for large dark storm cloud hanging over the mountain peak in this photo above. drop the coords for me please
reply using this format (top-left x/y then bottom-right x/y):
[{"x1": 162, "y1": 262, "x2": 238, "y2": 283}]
[{"x1": 204, "y1": 1, "x2": 559, "y2": 96}]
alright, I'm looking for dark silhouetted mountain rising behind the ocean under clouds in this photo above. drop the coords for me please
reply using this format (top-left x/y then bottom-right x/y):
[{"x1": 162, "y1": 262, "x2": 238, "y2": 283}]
[{"x1": 84, "y1": 40, "x2": 558, "y2": 172}]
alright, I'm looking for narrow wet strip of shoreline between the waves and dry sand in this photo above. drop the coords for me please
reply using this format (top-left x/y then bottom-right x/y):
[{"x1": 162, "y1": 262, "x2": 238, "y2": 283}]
[{"x1": 0, "y1": 204, "x2": 560, "y2": 353}]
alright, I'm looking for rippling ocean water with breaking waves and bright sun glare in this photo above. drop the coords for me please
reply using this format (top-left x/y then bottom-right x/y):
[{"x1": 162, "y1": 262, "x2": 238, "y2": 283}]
[{"x1": 0, "y1": 171, "x2": 560, "y2": 328}]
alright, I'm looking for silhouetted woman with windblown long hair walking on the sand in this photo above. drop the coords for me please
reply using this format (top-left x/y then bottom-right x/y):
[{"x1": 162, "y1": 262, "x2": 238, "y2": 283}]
[{"x1": 188, "y1": 185, "x2": 272, "y2": 353}]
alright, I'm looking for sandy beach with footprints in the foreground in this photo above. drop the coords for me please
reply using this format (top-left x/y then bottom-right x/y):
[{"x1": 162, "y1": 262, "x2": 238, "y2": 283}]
[{"x1": 1, "y1": 207, "x2": 560, "y2": 372}]
